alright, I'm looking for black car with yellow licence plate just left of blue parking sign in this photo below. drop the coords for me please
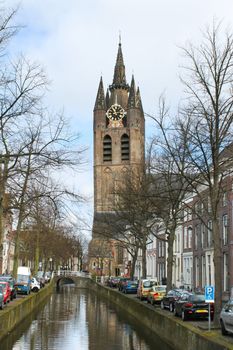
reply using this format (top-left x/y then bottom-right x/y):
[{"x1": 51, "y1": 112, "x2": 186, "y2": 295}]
[{"x1": 174, "y1": 293, "x2": 214, "y2": 321}]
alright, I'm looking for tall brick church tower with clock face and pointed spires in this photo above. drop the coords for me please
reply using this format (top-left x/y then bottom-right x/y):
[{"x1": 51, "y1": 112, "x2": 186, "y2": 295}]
[{"x1": 89, "y1": 43, "x2": 145, "y2": 275}]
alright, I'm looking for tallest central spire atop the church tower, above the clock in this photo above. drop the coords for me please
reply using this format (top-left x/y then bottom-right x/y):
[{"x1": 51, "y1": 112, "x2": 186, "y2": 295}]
[{"x1": 109, "y1": 41, "x2": 129, "y2": 90}]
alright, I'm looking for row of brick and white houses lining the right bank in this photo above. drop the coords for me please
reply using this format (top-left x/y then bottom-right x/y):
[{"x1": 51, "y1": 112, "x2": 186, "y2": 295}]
[{"x1": 124, "y1": 173, "x2": 233, "y2": 299}]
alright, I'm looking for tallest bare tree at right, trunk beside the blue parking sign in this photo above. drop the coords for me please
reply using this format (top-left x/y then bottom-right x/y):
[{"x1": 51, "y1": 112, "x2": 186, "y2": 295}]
[{"x1": 149, "y1": 24, "x2": 233, "y2": 323}]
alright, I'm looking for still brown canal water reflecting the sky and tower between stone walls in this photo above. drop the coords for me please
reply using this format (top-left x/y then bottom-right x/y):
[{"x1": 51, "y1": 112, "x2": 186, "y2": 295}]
[{"x1": 0, "y1": 285, "x2": 171, "y2": 350}]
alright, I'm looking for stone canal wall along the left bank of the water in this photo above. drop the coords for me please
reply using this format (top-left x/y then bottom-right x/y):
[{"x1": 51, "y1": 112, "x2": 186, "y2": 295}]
[{"x1": 0, "y1": 281, "x2": 54, "y2": 340}]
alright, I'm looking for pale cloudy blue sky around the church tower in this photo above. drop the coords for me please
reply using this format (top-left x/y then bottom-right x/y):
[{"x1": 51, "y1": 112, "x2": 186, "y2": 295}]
[{"x1": 6, "y1": 0, "x2": 233, "y2": 238}]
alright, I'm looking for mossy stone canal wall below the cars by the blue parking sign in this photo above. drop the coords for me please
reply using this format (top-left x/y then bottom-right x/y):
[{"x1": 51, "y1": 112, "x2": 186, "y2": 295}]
[{"x1": 88, "y1": 282, "x2": 233, "y2": 350}]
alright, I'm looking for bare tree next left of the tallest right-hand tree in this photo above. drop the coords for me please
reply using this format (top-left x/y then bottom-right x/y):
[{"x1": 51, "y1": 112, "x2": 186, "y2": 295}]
[{"x1": 148, "y1": 135, "x2": 190, "y2": 290}]
